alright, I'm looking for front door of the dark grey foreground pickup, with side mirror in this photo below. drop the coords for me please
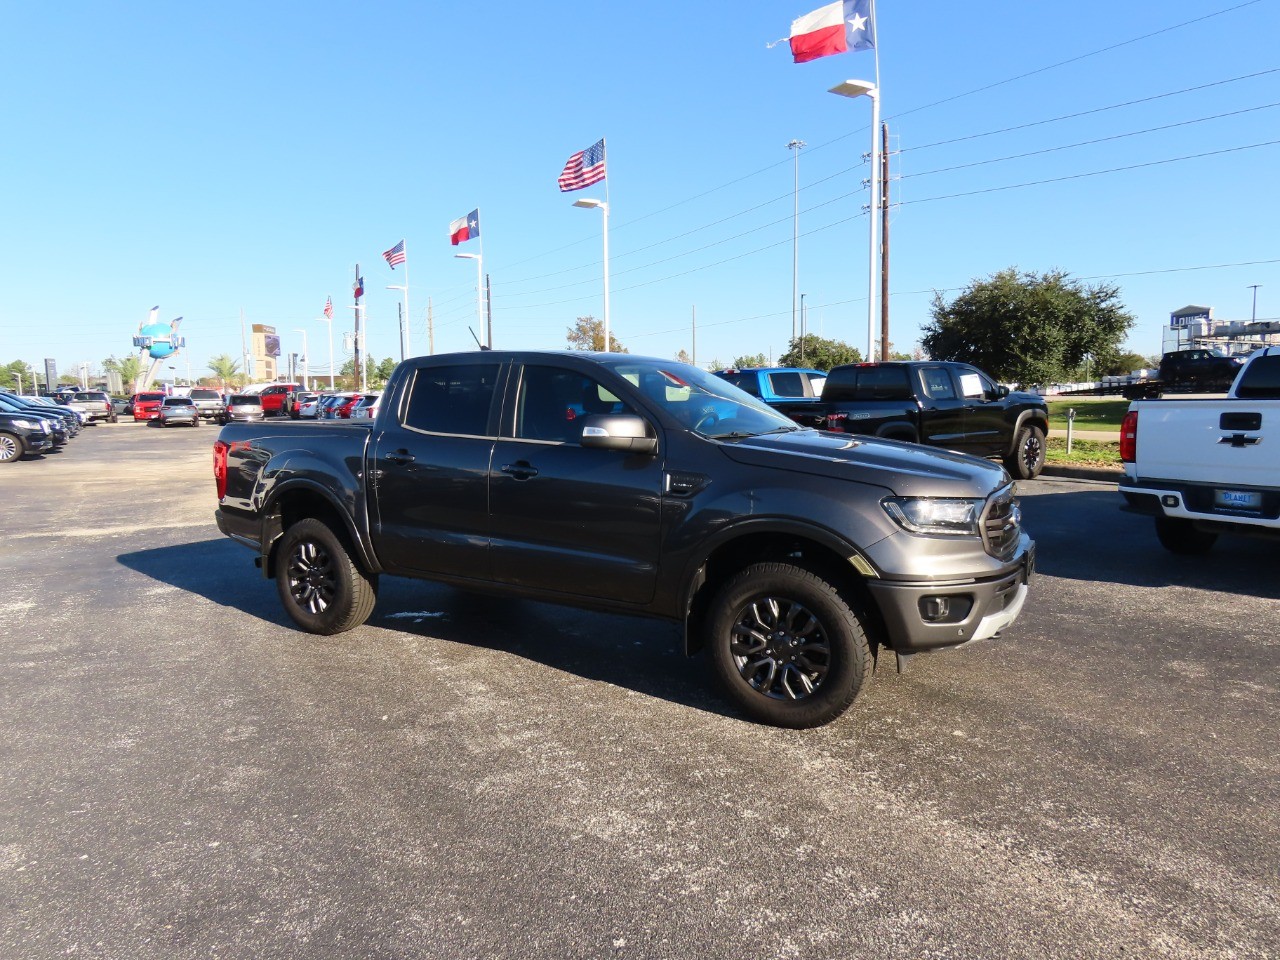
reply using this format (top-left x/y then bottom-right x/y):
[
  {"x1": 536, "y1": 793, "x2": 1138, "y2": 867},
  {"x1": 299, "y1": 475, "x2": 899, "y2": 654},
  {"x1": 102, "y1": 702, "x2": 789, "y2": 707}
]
[{"x1": 489, "y1": 364, "x2": 663, "y2": 604}]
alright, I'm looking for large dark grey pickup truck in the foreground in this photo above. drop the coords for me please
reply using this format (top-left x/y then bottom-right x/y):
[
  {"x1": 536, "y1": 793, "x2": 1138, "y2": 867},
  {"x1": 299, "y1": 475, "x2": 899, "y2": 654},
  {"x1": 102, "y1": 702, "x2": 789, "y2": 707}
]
[{"x1": 214, "y1": 351, "x2": 1034, "y2": 727}]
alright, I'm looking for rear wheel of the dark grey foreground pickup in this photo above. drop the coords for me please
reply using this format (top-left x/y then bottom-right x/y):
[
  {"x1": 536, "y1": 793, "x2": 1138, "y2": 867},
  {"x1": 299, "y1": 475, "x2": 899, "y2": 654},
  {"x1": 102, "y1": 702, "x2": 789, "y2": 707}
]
[{"x1": 275, "y1": 518, "x2": 378, "y2": 636}]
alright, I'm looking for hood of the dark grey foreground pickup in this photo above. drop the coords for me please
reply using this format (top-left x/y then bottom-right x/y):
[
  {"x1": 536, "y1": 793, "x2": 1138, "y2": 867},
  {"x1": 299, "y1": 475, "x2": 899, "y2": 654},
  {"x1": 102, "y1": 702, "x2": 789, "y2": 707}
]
[{"x1": 721, "y1": 430, "x2": 1009, "y2": 497}]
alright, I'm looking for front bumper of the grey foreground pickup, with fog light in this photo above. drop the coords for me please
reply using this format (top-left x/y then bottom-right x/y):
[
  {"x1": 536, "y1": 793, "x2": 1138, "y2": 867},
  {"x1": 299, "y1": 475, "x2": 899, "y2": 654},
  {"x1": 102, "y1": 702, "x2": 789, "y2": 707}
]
[{"x1": 867, "y1": 543, "x2": 1036, "y2": 655}]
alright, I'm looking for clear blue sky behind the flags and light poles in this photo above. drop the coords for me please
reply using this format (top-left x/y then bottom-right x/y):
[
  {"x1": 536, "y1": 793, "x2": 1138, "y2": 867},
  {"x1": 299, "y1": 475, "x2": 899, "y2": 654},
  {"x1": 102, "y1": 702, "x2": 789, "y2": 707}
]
[{"x1": 0, "y1": 0, "x2": 1280, "y2": 376}]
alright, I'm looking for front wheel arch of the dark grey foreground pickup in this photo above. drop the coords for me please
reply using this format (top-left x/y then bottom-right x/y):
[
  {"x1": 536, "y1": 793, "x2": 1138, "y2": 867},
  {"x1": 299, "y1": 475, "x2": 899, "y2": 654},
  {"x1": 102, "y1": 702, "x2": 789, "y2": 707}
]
[{"x1": 684, "y1": 522, "x2": 888, "y2": 657}]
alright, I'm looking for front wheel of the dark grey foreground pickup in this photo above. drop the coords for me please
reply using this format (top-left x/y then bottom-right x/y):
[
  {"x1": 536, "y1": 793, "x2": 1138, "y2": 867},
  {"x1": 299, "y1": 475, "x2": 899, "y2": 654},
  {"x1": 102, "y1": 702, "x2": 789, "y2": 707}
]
[{"x1": 707, "y1": 563, "x2": 870, "y2": 728}]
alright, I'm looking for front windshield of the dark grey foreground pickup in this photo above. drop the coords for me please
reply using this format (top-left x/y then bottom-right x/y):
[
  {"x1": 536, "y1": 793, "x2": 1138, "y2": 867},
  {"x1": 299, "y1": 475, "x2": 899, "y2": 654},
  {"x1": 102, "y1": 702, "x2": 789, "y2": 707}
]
[{"x1": 612, "y1": 360, "x2": 800, "y2": 440}]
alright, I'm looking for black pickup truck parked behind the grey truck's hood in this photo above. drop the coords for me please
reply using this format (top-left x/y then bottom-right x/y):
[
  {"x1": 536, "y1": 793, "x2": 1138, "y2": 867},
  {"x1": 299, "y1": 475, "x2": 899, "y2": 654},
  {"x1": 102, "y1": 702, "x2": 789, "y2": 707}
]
[{"x1": 773, "y1": 360, "x2": 1048, "y2": 480}]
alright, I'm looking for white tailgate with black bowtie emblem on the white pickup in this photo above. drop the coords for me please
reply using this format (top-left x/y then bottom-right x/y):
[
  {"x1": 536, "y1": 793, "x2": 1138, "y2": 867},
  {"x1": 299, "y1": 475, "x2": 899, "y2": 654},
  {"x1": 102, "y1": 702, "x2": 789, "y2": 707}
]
[{"x1": 1135, "y1": 399, "x2": 1280, "y2": 486}]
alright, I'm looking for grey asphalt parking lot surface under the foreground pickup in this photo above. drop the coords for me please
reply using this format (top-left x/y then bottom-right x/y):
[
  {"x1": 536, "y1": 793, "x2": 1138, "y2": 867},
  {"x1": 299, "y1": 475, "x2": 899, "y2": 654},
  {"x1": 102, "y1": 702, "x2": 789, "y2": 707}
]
[{"x1": 0, "y1": 422, "x2": 1280, "y2": 960}]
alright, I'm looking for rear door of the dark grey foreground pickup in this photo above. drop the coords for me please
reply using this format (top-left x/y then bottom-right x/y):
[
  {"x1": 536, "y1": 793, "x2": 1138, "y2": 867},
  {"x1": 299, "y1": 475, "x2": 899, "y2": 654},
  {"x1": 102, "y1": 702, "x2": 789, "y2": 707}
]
[{"x1": 370, "y1": 358, "x2": 504, "y2": 580}]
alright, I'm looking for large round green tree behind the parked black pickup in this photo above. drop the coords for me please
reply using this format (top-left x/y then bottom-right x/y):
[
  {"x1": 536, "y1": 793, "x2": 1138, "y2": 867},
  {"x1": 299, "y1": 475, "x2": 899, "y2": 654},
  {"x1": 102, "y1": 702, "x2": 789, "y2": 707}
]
[{"x1": 922, "y1": 268, "x2": 1134, "y2": 384}]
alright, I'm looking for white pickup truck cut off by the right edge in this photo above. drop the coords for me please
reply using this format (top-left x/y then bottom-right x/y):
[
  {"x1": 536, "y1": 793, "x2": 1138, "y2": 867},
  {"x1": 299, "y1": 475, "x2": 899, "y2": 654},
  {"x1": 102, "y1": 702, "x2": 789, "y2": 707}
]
[{"x1": 1120, "y1": 347, "x2": 1280, "y2": 553}]
